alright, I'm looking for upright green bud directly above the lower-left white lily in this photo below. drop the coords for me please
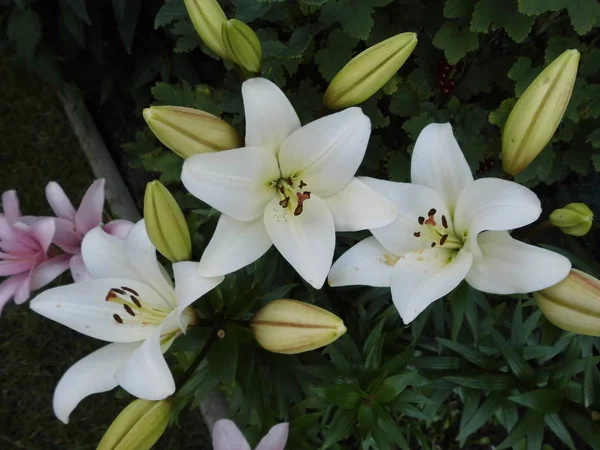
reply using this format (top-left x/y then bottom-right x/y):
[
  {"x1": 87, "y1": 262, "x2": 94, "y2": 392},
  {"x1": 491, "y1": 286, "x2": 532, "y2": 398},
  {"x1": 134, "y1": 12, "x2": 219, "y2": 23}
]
[{"x1": 144, "y1": 180, "x2": 192, "y2": 262}]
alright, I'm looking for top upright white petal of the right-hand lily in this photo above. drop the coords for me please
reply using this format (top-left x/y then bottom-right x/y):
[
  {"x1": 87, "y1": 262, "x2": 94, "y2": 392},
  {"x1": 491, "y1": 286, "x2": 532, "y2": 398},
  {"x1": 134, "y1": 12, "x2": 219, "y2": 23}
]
[{"x1": 410, "y1": 123, "x2": 473, "y2": 211}]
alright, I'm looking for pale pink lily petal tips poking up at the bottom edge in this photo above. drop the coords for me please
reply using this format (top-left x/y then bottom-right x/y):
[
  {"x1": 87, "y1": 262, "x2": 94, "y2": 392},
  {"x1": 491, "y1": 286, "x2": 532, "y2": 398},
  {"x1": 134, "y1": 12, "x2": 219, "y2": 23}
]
[{"x1": 212, "y1": 419, "x2": 289, "y2": 450}]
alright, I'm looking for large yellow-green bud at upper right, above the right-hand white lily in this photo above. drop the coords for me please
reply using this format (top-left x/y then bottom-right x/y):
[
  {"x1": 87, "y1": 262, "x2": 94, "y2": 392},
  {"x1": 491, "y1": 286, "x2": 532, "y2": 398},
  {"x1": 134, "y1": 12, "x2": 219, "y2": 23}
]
[{"x1": 502, "y1": 50, "x2": 579, "y2": 175}]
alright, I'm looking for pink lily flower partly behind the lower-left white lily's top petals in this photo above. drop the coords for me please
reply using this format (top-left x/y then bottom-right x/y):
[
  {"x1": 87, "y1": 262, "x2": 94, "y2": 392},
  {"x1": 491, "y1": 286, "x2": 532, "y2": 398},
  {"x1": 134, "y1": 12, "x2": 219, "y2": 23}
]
[{"x1": 46, "y1": 179, "x2": 133, "y2": 282}]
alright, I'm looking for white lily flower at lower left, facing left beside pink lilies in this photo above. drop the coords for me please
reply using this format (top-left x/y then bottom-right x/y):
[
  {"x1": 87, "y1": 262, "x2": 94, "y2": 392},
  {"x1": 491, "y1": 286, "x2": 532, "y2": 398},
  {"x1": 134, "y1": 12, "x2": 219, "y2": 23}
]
[{"x1": 31, "y1": 220, "x2": 223, "y2": 423}]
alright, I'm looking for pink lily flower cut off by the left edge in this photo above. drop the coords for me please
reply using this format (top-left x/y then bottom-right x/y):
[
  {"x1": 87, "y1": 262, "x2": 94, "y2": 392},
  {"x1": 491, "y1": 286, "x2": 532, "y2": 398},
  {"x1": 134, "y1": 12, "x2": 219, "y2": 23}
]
[{"x1": 0, "y1": 191, "x2": 69, "y2": 313}]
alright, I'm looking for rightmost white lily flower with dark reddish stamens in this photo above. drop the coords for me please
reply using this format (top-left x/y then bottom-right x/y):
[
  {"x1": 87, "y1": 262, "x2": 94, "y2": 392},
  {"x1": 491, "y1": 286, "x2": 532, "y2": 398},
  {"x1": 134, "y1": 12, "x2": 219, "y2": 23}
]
[{"x1": 329, "y1": 124, "x2": 571, "y2": 324}]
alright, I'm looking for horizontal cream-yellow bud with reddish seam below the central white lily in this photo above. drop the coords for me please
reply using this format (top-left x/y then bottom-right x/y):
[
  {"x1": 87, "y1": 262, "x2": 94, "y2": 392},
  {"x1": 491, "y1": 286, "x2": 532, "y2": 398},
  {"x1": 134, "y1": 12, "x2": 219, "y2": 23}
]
[{"x1": 250, "y1": 300, "x2": 346, "y2": 355}]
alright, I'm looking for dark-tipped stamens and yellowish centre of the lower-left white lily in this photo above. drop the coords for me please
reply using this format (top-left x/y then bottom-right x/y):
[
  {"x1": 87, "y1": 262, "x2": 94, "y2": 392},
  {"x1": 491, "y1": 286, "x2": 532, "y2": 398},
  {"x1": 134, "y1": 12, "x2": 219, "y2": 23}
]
[{"x1": 105, "y1": 286, "x2": 170, "y2": 325}]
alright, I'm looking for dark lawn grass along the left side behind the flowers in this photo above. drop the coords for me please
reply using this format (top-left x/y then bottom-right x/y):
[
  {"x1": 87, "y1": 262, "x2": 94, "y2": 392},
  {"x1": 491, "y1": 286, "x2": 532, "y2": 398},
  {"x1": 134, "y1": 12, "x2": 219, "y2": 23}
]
[{"x1": 0, "y1": 54, "x2": 210, "y2": 450}]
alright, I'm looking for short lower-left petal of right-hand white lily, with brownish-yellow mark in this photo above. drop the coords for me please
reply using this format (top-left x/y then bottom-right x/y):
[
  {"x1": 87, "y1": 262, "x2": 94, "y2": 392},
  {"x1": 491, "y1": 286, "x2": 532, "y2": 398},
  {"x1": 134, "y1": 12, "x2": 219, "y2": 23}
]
[{"x1": 327, "y1": 236, "x2": 398, "y2": 287}]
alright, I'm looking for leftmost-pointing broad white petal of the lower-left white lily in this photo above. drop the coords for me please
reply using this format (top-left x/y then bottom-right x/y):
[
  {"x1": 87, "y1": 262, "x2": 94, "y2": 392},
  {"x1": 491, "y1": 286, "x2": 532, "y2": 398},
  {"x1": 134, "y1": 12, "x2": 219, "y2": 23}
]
[{"x1": 30, "y1": 278, "x2": 168, "y2": 342}]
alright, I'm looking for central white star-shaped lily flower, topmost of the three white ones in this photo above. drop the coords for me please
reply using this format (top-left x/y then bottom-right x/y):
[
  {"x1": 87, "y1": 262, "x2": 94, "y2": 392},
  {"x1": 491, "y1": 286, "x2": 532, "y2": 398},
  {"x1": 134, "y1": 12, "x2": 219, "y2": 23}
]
[{"x1": 181, "y1": 78, "x2": 396, "y2": 289}]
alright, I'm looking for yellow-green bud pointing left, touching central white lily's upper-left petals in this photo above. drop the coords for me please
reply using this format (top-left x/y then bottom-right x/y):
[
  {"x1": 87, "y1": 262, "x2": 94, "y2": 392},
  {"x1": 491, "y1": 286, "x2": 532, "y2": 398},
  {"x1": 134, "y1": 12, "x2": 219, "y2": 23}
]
[{"x1": 144, "y1": 106, "x2": 242, "y2": 158}]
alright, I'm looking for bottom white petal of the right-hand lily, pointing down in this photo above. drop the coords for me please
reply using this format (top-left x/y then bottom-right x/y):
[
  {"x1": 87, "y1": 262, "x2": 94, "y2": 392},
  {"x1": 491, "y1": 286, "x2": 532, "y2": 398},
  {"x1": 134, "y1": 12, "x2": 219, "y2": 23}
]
[{"x1": 392, "y1": 249, "x2": 473, "y2": 324}]
